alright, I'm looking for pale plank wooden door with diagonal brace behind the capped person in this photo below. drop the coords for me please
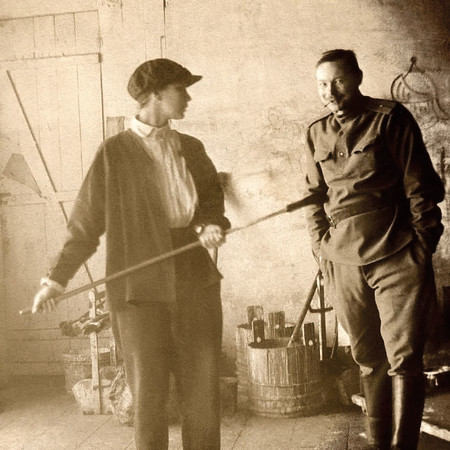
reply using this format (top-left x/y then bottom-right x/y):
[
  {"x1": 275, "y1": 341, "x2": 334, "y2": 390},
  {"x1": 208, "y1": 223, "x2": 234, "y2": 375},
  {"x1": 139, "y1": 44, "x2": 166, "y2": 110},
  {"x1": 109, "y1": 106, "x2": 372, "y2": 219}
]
[{"x1": 0, "y1": 11, "x2": 109, "y2": 374}]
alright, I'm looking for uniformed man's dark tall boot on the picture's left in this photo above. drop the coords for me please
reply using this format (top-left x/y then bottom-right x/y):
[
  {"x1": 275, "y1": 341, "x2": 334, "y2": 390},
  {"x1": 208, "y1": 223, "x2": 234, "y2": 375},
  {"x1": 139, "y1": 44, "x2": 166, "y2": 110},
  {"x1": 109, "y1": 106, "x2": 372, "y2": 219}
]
[{"x1": 361, "y1": 362, "x2": 392, "y2": 450}]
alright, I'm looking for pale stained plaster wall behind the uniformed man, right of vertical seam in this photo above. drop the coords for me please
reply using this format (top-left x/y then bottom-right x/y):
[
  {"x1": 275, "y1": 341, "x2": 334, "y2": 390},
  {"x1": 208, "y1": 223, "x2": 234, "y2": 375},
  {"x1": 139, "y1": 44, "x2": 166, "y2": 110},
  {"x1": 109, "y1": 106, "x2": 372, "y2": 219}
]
[{"x1": 164, "y1": 0, "x2": 450, "y2": 366}]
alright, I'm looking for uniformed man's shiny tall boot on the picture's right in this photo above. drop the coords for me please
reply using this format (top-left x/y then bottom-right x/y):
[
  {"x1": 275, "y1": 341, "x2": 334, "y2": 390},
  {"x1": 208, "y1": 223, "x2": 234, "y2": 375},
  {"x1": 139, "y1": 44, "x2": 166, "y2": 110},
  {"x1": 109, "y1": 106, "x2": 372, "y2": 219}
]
[{"x1": 391, "y1": 374, "x2": 425, "y2": 450}]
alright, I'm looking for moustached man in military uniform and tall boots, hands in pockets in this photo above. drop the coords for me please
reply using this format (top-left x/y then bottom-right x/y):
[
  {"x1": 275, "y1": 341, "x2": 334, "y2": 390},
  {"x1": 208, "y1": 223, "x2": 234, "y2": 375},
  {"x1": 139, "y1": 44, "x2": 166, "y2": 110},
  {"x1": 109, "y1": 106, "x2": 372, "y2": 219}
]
[{"x1": 306, "y1": 49, "x2": 444, "y2": 449}]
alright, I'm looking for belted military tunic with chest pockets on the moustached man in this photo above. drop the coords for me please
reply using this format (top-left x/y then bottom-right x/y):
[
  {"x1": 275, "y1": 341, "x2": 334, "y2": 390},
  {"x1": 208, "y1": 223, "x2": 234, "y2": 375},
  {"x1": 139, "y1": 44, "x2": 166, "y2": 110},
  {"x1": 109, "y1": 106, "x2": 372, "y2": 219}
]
[{"x1": 306, "y1": 97, "x2": 444, "y2": 265}]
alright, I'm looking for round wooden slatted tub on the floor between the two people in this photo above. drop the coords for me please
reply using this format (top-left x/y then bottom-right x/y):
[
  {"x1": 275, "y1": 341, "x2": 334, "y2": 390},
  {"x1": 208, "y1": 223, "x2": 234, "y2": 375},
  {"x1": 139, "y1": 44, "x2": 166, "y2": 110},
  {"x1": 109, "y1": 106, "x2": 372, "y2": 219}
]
[{"x1": 248, "y1": 339, "x2": 324, "y2": 417}]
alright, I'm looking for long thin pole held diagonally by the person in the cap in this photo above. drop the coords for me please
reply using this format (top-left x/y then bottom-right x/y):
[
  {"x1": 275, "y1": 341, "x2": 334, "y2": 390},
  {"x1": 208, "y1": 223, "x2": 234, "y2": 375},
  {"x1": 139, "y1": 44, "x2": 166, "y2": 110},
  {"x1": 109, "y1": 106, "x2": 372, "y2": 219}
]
[{"x1": 19, "y1": 198, "x2": 313, "y2": 315}]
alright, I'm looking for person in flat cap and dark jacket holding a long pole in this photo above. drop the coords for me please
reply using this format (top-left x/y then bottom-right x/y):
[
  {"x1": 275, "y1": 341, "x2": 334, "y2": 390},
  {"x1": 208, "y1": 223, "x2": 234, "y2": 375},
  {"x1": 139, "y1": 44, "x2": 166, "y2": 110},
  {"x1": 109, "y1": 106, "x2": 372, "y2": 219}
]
[{"x1": 32, "y1": 59, "x2": 230, "y2": 450}]
